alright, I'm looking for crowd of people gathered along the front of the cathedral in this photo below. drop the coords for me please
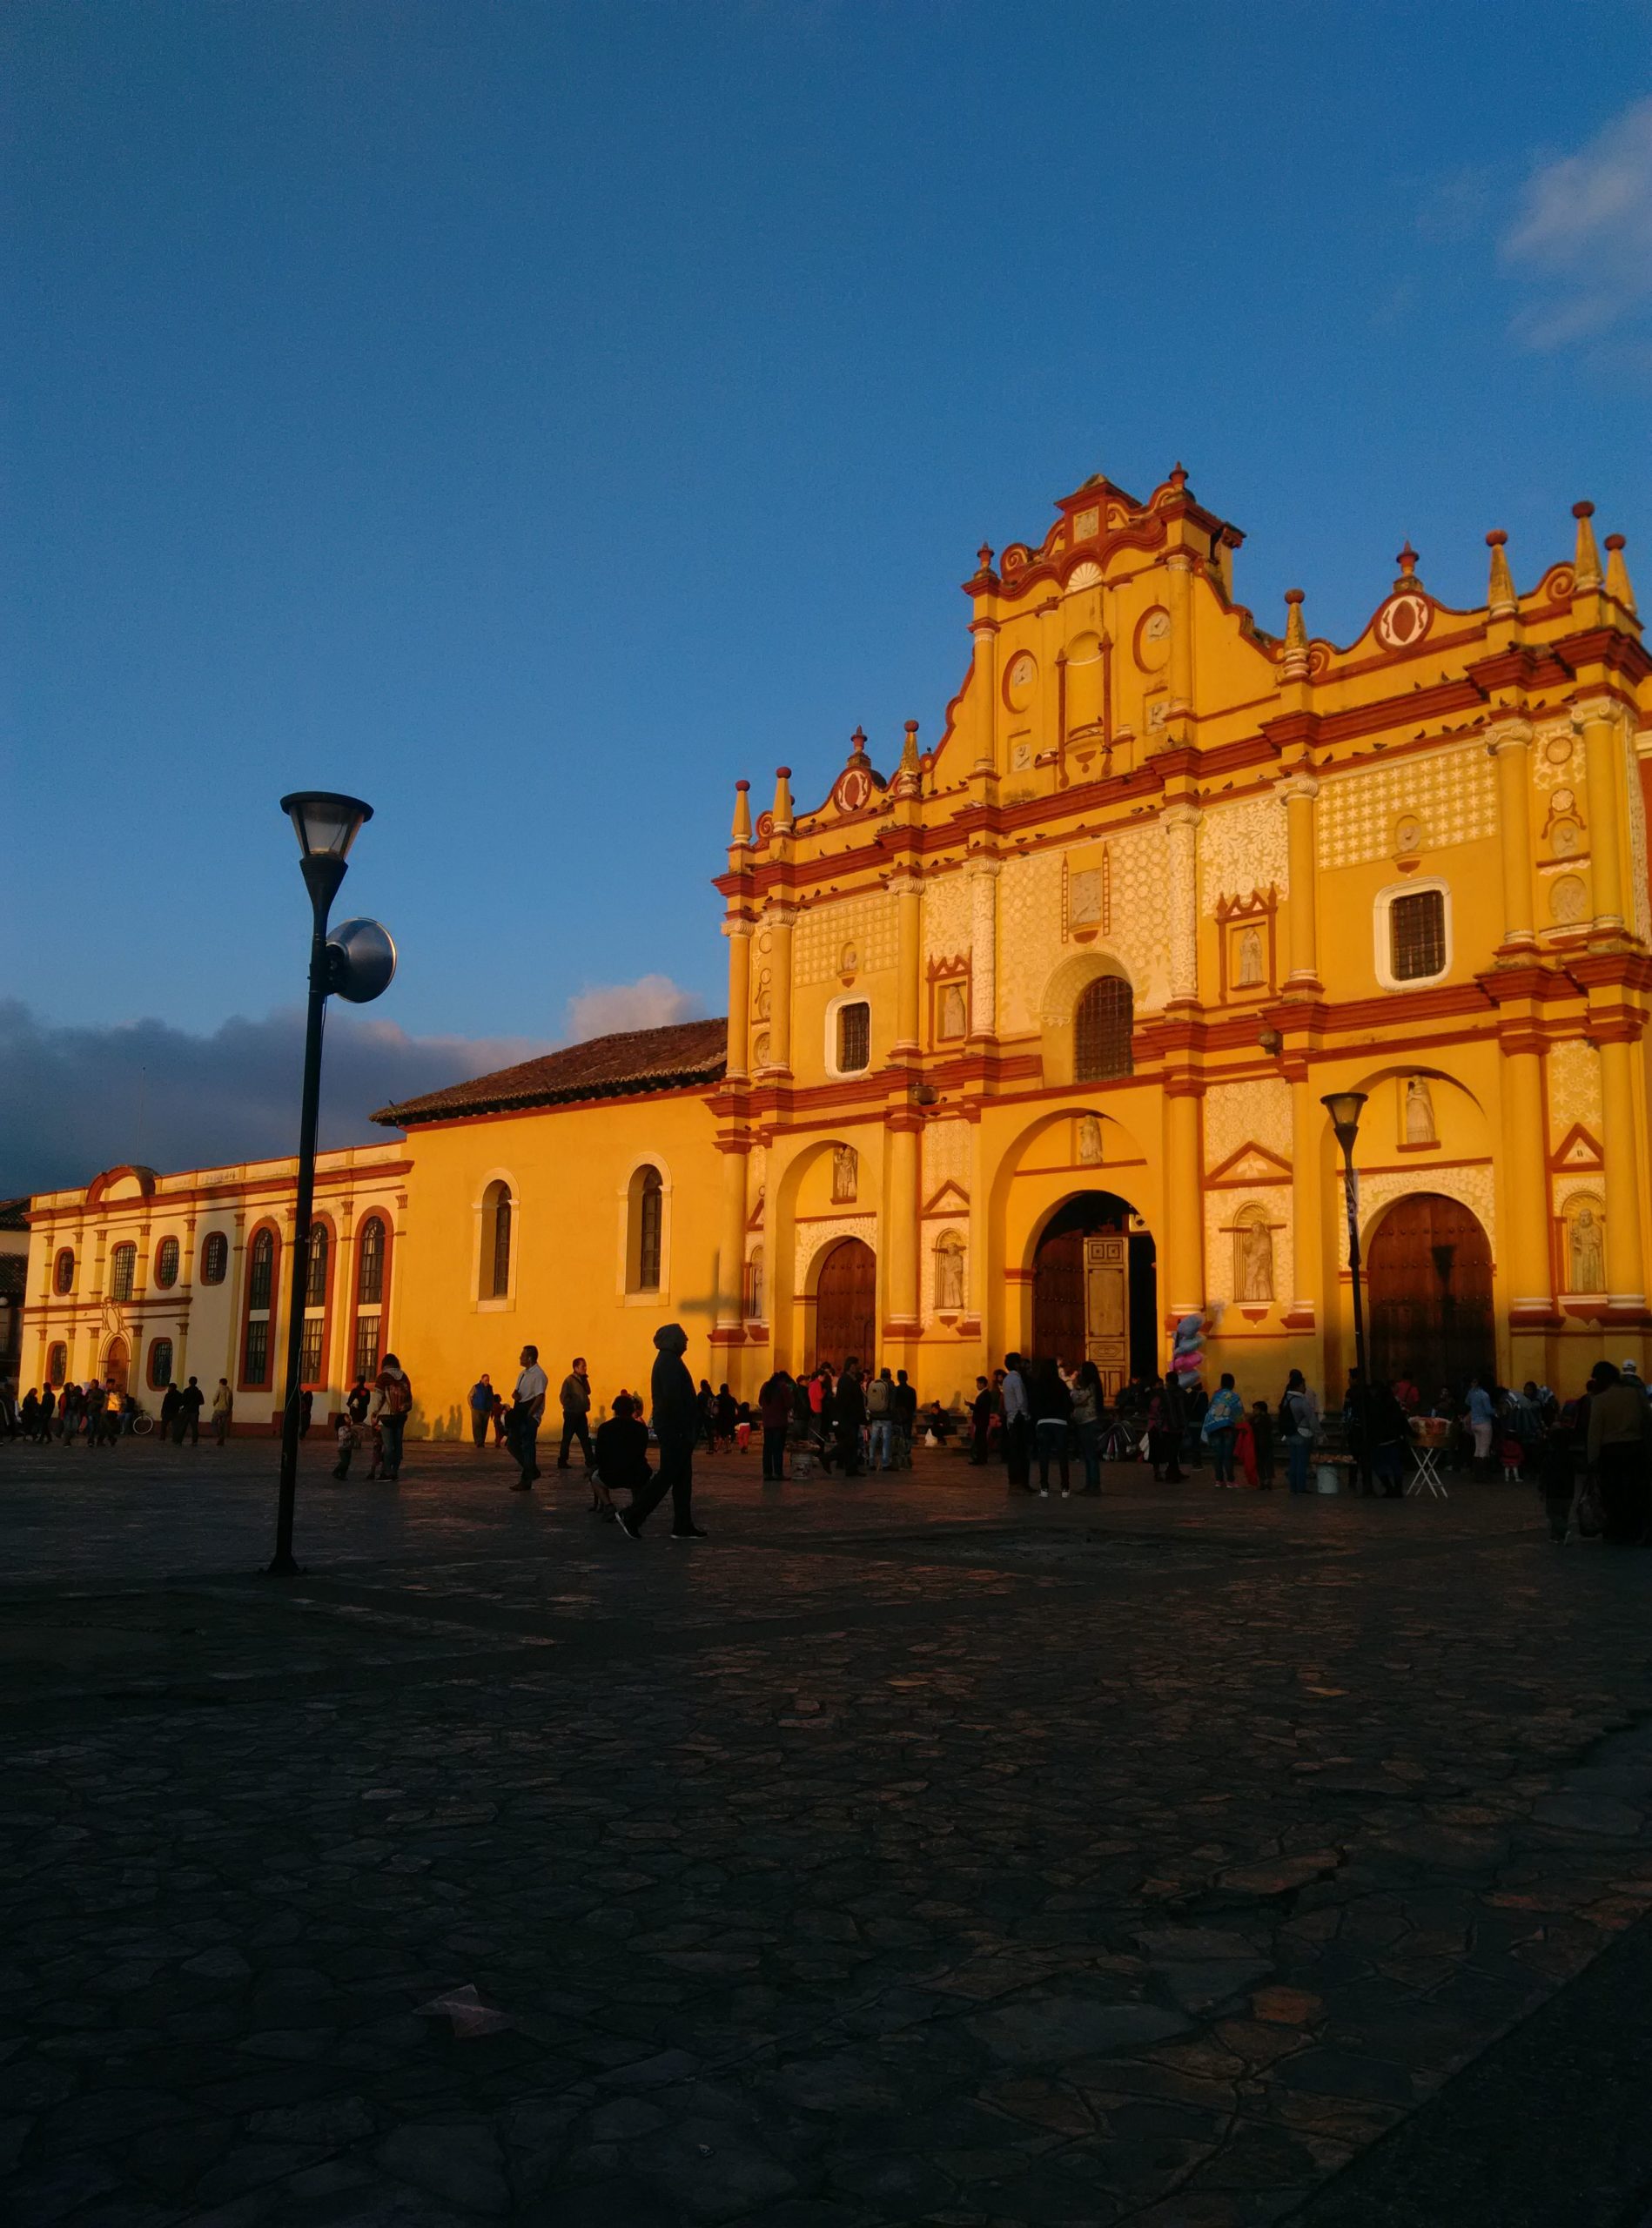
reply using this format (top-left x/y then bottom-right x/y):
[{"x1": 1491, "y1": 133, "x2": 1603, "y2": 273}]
[{"x1": 12, "y1": 1324, "x2": 1652, "y2": 1544}]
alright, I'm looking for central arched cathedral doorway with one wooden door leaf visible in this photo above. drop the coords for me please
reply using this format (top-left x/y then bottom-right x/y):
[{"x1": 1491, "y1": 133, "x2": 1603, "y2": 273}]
[{"x1": 1032, "y1": 1192, "x2": 1159, "y2": 1395}]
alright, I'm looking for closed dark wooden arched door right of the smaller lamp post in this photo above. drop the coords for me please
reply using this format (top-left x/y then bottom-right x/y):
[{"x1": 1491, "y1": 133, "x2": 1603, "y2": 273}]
[{"x1": 1365, "y1": 1192, "x2": 1496, "y2": 1392}]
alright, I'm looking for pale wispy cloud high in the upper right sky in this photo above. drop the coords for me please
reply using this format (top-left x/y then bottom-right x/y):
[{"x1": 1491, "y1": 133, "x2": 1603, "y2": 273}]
[{"x1": 1502, "y1": 96, "x2": 1652, "y2": 350}]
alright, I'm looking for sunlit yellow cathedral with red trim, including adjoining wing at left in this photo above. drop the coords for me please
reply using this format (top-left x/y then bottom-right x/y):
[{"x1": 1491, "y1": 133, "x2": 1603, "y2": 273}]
[{"x1": 23, "y1": 468, "x2": 1652, "y2": 1435}]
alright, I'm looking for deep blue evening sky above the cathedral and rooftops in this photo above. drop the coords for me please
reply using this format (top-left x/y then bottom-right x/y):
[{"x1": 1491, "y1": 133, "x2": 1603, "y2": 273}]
[{"x1": 0, "y1": 0, "x2": 1652, "y2": 1185}]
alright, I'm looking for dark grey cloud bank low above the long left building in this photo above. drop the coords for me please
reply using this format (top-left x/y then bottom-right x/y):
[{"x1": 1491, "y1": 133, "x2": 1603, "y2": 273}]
[{"x1": 0, "y1": 998, "x2": 547, "y2": 1197}]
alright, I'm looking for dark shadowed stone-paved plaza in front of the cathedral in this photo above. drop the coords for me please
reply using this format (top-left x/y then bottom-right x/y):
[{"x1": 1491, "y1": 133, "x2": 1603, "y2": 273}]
[{"x1": 0, "y1": 1441, "x2": 1652, "y2": 2228}]
